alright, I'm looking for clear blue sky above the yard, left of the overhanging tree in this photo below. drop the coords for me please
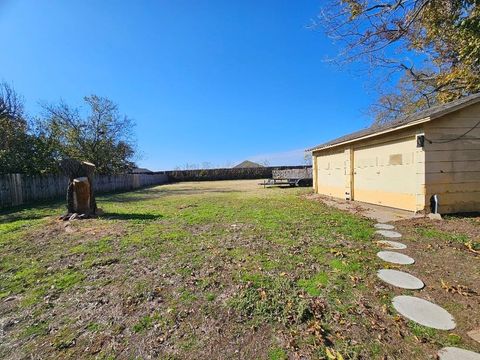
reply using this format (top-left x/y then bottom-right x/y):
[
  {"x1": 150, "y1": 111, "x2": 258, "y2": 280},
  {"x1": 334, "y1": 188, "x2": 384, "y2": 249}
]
[{"x1": 0, "y1": 0, "x2": 373, "y2": 170}]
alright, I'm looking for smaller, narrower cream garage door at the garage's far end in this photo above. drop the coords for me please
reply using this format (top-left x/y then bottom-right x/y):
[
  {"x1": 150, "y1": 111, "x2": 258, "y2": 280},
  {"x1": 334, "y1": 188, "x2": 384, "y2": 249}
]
[{"x1": 316, "y1": 151, "x2": 345, "y2": 199}]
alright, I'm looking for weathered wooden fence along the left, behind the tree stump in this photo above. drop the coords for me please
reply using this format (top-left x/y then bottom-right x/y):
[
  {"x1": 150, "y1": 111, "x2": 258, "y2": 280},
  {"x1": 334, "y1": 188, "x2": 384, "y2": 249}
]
[{"x1": 0, "y1": 173, "x2": 168, "y2": 209}]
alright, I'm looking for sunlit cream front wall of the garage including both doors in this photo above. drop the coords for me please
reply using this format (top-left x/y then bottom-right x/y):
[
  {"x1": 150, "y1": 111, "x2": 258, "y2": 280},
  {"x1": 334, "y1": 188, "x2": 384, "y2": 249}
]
[{"x1": 313, "y1": 125, "x2": 428, "y2": 211}]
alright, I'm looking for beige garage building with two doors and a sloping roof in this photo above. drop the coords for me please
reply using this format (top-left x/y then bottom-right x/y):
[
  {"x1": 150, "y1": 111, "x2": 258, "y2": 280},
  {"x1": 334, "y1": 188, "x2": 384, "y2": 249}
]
[{"x1": 309, "y1": 94, "x2": 480, "y2": 214}]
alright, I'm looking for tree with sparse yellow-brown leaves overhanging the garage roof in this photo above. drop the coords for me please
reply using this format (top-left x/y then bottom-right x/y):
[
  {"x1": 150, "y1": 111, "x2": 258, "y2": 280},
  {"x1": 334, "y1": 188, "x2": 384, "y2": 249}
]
[{"x1": 318, "y1": 0, "x2": 480, "y2": 121}]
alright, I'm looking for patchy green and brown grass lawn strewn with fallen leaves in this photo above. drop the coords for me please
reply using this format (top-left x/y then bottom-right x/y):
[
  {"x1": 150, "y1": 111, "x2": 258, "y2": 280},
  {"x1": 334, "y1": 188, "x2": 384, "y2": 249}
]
[{"x1": 0, "y1": 181, "x2": 478, "y2": 360}]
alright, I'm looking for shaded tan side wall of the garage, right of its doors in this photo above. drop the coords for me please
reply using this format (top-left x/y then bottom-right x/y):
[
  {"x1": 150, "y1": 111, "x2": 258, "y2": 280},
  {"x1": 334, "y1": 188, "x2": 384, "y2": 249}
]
[{"x1": 424, "y1": 104, "x2": 480, "y2": 214}]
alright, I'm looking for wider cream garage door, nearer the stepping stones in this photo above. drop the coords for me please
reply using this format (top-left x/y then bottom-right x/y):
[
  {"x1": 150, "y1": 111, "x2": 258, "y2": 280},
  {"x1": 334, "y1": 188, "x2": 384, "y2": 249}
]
[{"x1": 353, "y1": 136, "x2": 417, "y2": 211}]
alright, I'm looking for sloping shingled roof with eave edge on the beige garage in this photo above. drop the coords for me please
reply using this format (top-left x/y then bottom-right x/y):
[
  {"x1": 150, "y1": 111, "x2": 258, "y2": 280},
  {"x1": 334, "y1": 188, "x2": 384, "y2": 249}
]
[{"x1": 307, "y1": 93, "x2": 480, "y2": 151}]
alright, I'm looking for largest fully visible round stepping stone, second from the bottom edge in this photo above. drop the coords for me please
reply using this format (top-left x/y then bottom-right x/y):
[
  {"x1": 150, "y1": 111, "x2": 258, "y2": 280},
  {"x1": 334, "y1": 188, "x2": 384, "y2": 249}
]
[{"x1": 392, "y1": 295, "x2": 456, "y2": 330}]
